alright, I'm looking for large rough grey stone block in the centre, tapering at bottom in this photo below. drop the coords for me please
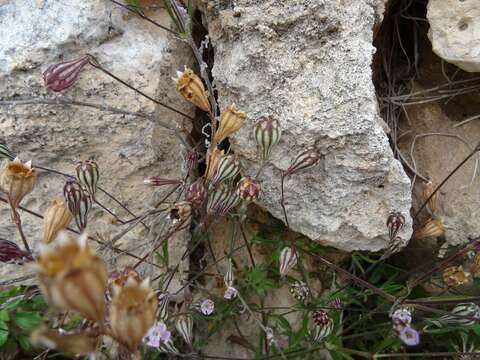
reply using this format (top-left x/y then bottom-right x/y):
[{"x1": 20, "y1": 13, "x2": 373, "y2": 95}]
[{"x1": 208, "y1": 0, "x2": 411, "y2": 250}]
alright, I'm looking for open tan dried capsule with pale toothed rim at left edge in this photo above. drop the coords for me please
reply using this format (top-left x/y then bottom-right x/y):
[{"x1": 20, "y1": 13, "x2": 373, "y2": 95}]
[{"x1": 0, "y1": 158, "x2": 37, "y2": 209}]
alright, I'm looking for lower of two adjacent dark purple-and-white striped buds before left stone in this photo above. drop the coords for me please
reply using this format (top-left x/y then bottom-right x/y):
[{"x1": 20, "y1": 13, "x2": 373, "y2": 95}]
[{"x1": 63, "y1": 180, "x2": 92, "y2": 231}]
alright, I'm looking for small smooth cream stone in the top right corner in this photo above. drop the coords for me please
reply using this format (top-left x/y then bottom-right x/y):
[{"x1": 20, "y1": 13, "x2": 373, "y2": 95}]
[{"x1": 427, "y1": 0, "x2": 480, "y2": 72}]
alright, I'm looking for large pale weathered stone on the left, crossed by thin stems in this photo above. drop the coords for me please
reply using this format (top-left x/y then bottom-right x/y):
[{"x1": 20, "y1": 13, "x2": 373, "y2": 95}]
[{"x1": 0, "y1": 0, "x2": 193, "y2": 284}]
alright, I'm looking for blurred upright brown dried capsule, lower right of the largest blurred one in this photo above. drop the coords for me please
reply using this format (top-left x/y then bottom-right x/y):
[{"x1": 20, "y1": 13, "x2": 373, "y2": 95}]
[{"x1": 110, "y1": 277, "x2": 158, "y2": 351}]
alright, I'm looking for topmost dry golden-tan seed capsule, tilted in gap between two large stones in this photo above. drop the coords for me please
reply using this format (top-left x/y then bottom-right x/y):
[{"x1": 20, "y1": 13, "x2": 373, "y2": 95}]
[{"x1": 173, "y1": 66, "x2": 211, "y2": 112}]
